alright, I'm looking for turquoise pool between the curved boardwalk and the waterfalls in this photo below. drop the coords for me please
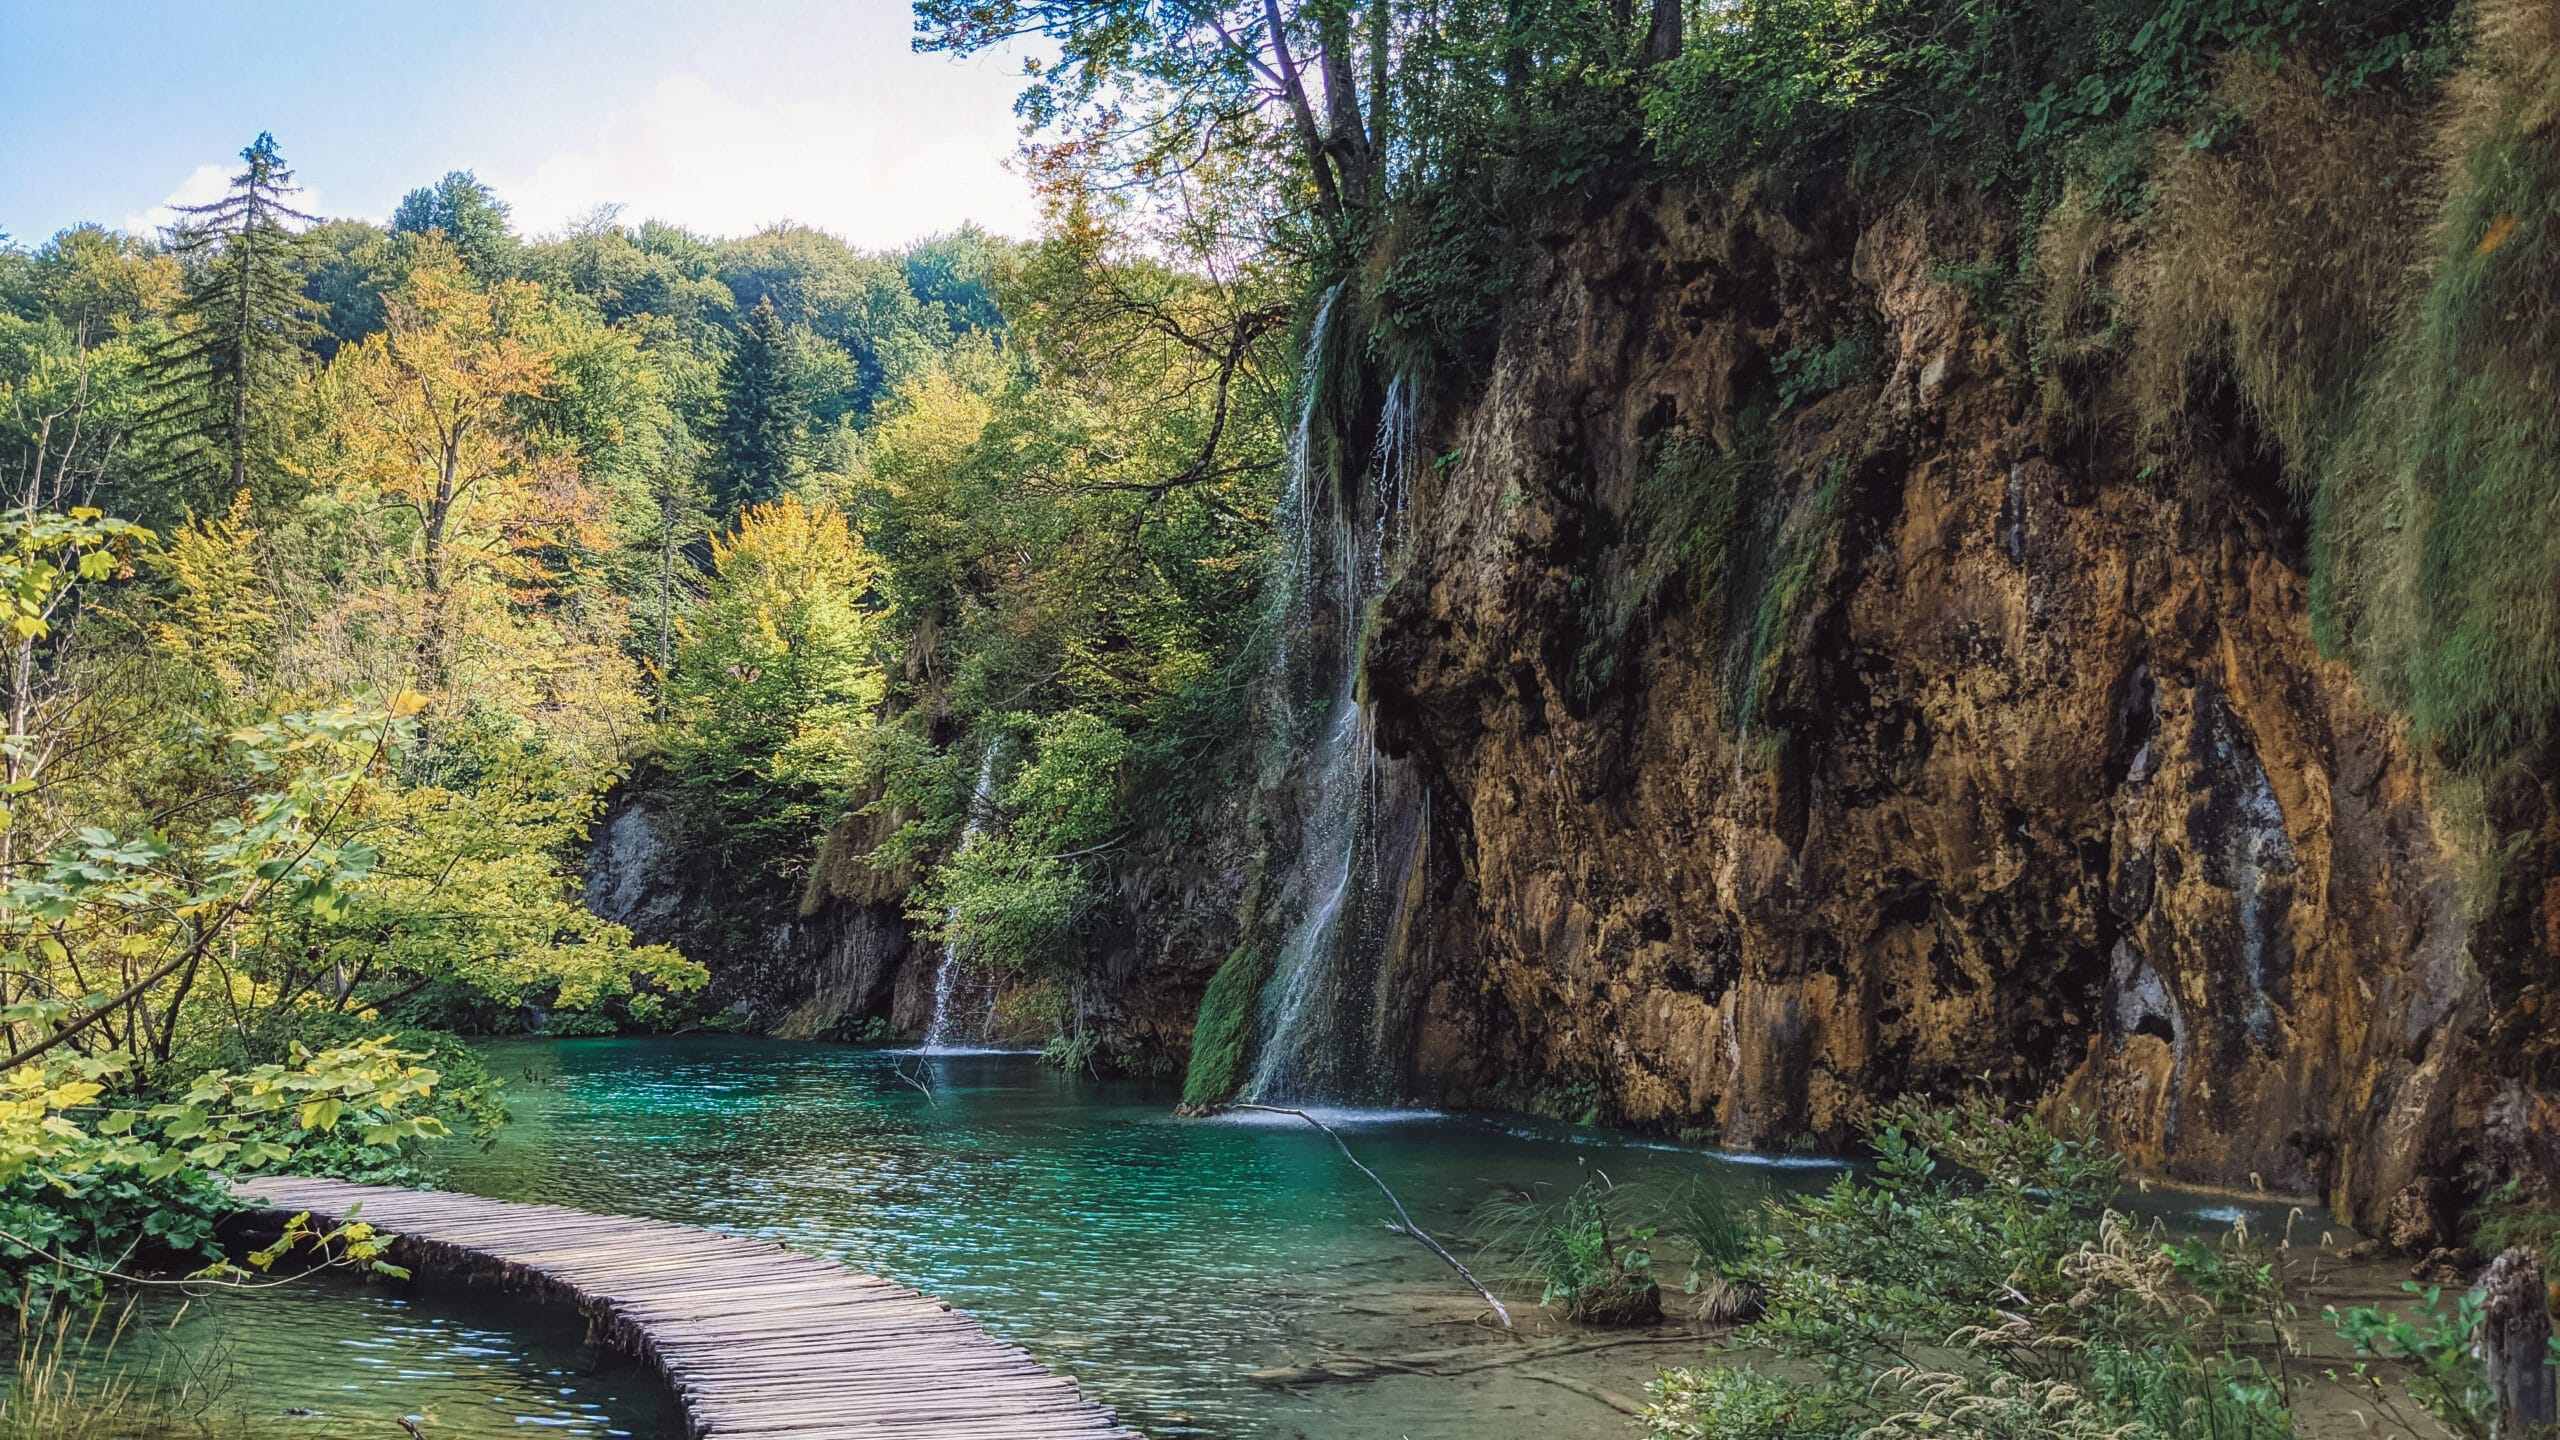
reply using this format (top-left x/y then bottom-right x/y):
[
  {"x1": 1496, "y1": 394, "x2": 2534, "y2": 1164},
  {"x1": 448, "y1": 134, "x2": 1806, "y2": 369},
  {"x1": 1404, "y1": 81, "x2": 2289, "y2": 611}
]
[{"x1": 443, "y1": 1040, "x2": 1825, "y2": 1440}]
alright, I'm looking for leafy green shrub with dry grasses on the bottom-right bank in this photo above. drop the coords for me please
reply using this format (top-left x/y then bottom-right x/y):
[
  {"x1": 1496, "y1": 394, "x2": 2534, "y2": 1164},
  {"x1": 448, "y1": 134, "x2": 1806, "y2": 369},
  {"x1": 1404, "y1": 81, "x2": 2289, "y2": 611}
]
[{"x1": 1646, "y1": 1102, "x2": 2291, "y2": 1440}]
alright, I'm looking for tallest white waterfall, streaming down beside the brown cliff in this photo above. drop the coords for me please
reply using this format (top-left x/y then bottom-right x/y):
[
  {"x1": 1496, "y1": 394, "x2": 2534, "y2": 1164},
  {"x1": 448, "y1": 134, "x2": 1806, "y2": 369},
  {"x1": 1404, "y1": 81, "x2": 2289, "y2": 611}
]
[{"x1": 1244, "y1": 299, "x2": 1423, "y2": 1102}]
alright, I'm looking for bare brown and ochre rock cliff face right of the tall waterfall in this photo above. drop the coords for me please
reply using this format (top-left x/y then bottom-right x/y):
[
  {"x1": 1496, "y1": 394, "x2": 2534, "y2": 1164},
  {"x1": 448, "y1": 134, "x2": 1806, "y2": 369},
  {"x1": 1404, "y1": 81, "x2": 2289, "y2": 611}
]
[{"x1": 1367, "y1": 179, "x2": 2483, "y2": 1220}]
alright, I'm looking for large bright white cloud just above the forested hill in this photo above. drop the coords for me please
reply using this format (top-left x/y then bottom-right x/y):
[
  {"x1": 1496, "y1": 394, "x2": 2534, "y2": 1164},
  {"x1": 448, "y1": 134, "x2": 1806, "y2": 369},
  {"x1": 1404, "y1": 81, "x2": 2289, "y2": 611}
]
[{"x1": 481, "y1": 74, "x2": 1037, "y2": 249}]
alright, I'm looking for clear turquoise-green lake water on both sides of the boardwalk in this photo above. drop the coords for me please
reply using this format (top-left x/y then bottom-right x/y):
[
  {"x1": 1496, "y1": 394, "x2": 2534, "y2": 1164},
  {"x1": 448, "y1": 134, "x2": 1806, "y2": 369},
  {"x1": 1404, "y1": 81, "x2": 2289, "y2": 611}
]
[{"x1": 154, "y1": 1038, "x2": 2324, "y2": 1440}]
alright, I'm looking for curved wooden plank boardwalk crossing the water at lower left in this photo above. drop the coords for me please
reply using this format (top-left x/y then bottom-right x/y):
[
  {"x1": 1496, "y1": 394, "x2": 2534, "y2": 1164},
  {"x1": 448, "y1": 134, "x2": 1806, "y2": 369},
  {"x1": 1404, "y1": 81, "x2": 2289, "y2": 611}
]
[{"x1": 233, "y1": 1176, "x2": 1137, "y2": 1440}]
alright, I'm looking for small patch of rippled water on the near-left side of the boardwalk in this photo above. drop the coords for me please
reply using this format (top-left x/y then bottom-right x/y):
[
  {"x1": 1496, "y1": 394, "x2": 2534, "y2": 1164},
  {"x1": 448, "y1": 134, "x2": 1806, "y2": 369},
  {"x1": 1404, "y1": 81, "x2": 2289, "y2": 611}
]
[{"x1": 92, "y1": 1276, "x2": 684, "y2": 1440}]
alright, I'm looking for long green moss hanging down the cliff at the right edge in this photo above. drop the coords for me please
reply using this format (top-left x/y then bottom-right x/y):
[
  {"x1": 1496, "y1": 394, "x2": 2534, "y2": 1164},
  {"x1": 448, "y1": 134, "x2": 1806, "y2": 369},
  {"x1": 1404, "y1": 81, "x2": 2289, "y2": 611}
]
[{"x1": 2312, "y1": 33, "x2": 2560, "y2": 771}]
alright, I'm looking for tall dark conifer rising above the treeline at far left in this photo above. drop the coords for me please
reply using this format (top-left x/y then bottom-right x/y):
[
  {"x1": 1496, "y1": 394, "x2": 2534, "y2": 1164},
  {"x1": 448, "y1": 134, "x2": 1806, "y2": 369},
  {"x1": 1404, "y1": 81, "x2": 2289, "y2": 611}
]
[{"x1": 143, "y1": 131, "x2": 320, "y2": 515}]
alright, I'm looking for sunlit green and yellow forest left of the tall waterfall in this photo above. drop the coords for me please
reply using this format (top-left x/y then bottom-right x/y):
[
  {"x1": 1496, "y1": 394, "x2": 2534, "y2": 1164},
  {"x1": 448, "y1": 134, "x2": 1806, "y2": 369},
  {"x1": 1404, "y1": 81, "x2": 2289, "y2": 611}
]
[{"x1": 0, "y1": 136, "x2": 1285, "y2": 1301}]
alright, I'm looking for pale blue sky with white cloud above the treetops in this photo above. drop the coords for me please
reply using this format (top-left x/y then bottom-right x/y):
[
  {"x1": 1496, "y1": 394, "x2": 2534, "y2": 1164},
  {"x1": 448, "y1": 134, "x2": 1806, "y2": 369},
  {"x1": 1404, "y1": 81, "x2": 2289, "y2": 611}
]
[{"x1": 0, "y1": 0, "x2": 1034, "y2": 249}]
